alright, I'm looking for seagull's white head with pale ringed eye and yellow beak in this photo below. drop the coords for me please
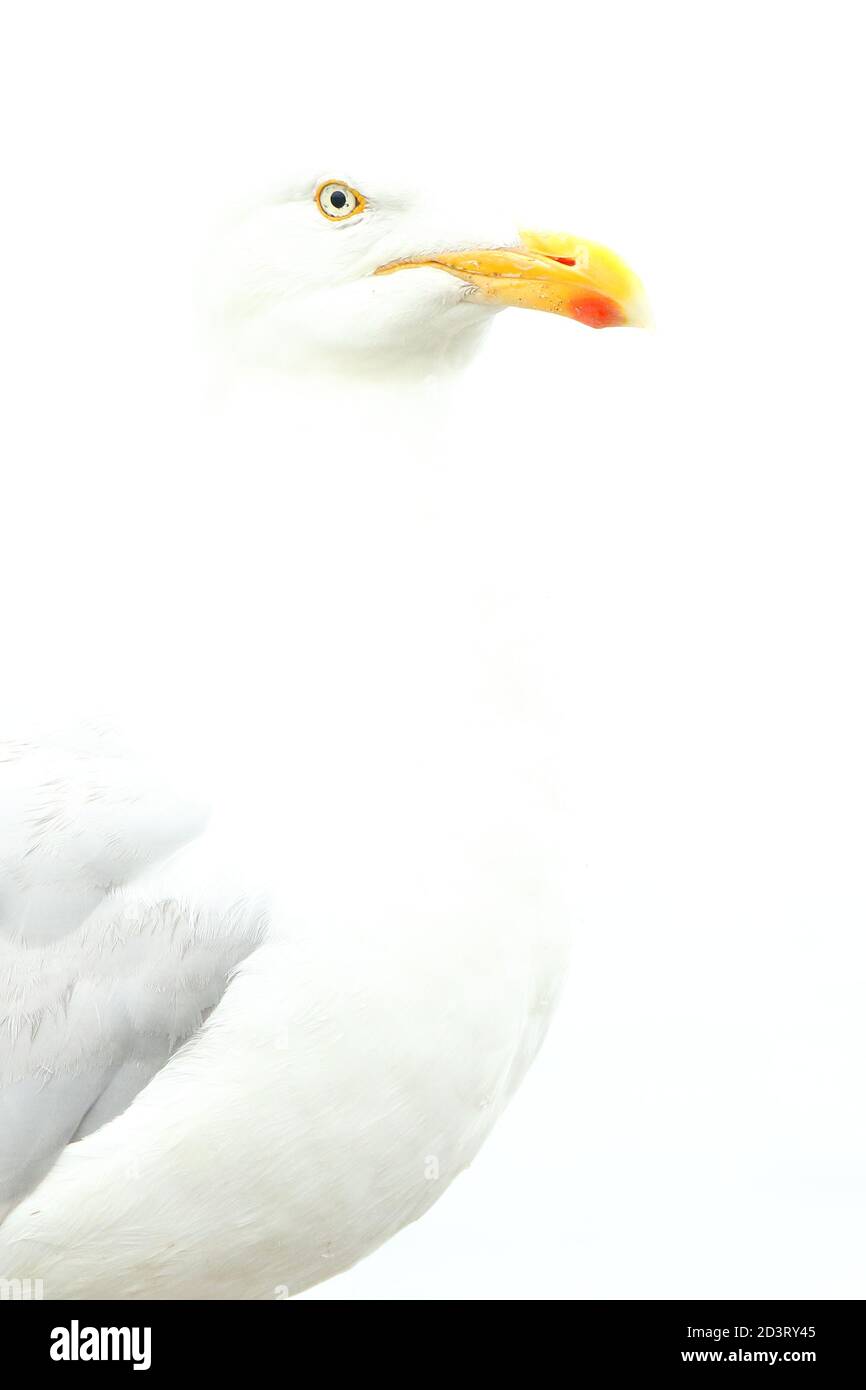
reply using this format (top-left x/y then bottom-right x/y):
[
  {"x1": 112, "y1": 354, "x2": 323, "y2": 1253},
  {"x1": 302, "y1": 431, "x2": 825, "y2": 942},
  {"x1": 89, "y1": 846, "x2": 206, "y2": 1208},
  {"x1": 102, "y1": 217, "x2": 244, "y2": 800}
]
[{"x1": 209, "y1": 168, "x2": 649, "y2": 375}]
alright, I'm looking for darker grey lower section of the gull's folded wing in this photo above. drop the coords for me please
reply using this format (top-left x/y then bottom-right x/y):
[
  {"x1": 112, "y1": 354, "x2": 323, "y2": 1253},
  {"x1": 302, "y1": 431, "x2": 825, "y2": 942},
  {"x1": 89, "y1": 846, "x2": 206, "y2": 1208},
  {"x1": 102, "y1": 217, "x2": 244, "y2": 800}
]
[{"x1": 0, "y1": 890, "x2": 264, "y2": 1220}]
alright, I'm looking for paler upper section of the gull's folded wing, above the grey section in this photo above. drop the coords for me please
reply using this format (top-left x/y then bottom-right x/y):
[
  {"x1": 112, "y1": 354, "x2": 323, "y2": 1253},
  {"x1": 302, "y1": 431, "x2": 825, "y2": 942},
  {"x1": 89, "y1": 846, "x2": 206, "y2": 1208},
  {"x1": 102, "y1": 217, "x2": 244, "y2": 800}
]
[{"x1": 0, "y1": 726, "x2": 207, "y2": 944}]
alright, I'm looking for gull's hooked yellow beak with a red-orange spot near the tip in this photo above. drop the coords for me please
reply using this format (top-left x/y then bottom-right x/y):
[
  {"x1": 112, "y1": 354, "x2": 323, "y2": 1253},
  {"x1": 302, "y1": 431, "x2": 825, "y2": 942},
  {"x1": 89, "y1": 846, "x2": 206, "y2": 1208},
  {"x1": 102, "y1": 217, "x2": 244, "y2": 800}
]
[{"x1": 375, "y1": 232, "x2": 651, "y2": 328}]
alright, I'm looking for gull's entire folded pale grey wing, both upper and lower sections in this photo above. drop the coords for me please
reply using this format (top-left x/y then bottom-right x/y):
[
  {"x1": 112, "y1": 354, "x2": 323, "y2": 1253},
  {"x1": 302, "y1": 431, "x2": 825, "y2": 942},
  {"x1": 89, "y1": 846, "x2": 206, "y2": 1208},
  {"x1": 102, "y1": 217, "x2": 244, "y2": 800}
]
[{"x1": 0, "y1": 728, "x2": 264, "y2": 1220}]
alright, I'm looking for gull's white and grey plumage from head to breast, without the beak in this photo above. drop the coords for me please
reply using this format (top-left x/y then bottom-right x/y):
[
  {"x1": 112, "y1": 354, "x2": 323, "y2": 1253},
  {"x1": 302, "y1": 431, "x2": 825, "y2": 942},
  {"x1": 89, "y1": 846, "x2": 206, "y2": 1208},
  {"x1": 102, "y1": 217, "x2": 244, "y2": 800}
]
[{"x1": 0, "y1": 171, "x2": 639, "y2": 1298}]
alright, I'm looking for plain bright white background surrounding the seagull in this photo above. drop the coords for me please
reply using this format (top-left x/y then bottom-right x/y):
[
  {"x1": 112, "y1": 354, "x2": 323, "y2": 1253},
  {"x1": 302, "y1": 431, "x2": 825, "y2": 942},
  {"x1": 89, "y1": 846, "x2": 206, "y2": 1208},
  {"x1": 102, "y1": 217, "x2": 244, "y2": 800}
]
[{"x1": 0, "y1": 0, "x2": 866, "y2": 1298}]
